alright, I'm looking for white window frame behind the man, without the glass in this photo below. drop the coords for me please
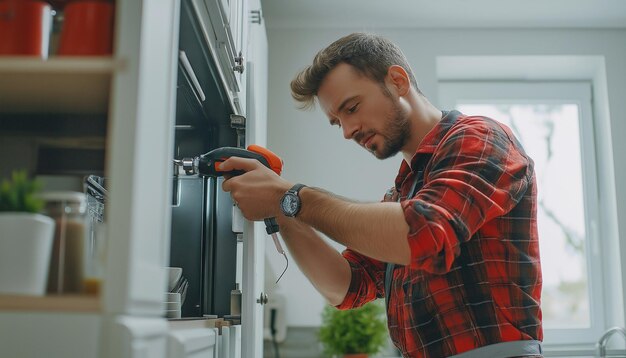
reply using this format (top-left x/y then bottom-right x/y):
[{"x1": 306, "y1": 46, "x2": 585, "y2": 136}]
[{"x1": 439, "y1": 81, "x2": 610, "y2": 346}]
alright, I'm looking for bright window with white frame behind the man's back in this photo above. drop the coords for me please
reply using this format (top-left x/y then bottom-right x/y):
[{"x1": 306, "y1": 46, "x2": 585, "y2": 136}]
[{"x1": 440, "y1": 82, "x2": 604, "y2": 344}]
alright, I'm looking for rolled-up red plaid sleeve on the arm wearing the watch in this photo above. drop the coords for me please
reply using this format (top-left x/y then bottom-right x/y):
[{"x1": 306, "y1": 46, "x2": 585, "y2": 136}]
[{"x1": 401, "y1": 117, "x2": 532, "y2": 274}]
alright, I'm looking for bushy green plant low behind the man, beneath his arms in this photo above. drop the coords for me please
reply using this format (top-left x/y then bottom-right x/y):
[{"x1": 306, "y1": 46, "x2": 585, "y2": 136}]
[{"x1": 319, "y1": 302, "x2": 388, "y2": 358}]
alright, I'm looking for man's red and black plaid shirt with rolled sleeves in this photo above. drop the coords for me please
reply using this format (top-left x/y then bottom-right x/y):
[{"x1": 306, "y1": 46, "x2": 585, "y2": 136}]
[{"x1": 337, "y1": 111, "x2": 543, "y2": 358}]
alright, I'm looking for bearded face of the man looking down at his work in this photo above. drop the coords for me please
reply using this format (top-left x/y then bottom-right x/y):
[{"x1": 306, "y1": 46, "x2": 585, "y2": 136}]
[{"x1": 317, "y1": 63, "x2": 411, "y2": 159}]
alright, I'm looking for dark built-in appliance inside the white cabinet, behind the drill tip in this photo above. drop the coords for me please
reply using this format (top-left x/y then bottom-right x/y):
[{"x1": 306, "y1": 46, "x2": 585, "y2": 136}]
[{"x1": 170, "y1": 0, "x2": 241, "y2": 317}]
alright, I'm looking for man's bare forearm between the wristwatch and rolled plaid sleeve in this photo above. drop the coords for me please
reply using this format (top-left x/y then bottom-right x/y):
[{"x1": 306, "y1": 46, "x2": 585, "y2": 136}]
[{"x1": 297, "y1": 188, "x2": 411, "y2": 265}]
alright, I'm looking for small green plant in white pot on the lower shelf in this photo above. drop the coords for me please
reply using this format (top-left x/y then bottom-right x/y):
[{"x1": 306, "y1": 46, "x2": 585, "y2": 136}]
[{"x1": 0, "y1": 171, "x2": 54, "y2": 295}]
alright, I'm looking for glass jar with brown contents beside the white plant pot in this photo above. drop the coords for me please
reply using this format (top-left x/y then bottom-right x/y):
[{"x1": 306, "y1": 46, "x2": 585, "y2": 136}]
[{"x1": 41, "y1": 191, "x2": 87, "y2": 293}]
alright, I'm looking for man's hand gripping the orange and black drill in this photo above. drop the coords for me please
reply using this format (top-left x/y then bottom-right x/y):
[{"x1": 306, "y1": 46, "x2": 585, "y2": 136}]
[{"x1": 219, "y1": 157, "x2": 292, "y2": 221}]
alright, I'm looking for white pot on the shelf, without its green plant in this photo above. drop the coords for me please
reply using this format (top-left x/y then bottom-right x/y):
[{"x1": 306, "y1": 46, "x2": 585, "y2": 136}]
[{"x1": 0, "y1": 212, "x2": 54, "y2": 296}]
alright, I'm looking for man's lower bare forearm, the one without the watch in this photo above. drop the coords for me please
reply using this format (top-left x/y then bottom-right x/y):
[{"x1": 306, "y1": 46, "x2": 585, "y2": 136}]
[{"x1": 278, "y1": 216, "x2": 352, "y2": 305}]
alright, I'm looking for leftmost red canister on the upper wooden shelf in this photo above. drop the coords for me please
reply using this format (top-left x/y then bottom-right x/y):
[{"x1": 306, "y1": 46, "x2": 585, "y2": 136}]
[{"x1": 0, "y1": 0, "x2": 52, "y2": 58}]
